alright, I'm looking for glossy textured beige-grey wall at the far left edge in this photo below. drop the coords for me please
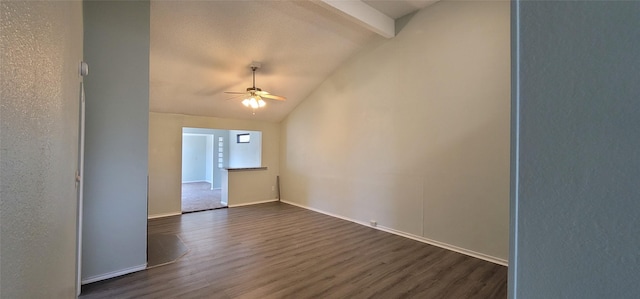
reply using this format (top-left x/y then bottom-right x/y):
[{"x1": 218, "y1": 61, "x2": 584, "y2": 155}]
[{"x1": 0, "y1": 1, "x2": 82, "y2": 298}]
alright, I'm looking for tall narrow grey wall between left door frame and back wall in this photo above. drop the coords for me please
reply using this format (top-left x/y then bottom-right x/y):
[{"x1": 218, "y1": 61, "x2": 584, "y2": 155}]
[{"x1": 82, "y1": 1, "x2": 149, "y2": 282}]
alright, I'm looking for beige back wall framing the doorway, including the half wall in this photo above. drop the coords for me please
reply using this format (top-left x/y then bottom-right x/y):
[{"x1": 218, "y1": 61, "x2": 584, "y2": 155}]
[{"x1": 149, "y1": 112, "x2": 280, "y2": 217}]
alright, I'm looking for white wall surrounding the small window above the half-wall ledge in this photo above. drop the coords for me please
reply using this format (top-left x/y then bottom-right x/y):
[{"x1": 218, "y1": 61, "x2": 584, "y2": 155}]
[{"x1": 228, "y1": 130, "x2": 262, "y2": 168}]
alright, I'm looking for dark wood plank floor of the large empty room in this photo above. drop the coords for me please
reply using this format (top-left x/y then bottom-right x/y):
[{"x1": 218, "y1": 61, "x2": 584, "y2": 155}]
[{"x1": 81, "y1": 202, "x2": 507, "y2": 298}]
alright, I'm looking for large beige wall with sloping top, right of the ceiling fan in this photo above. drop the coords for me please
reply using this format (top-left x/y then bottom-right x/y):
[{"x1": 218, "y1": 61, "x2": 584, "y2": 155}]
[{"x1": 280, "y1": 1, "x2": 510, "y2": 262}]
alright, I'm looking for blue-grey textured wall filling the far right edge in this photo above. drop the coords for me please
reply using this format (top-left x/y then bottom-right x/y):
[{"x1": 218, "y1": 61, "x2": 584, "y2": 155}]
[{"x1": 509, "y1": 1, "x2": 640, "y2": 298}]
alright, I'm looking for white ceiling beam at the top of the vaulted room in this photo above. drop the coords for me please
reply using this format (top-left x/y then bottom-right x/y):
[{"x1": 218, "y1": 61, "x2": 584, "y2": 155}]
[{"x1": 316, "y1": 0, "x2": 396, "y2": 38}]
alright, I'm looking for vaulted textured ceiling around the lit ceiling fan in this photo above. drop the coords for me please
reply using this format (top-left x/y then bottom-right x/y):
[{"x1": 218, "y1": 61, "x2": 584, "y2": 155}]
[{"x1": 149, "y1": 0, "x2": 435, "y2": 122}]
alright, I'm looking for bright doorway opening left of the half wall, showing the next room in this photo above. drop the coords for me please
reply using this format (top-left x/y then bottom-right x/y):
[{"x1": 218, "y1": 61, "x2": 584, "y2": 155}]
[{"x1": 181, "y1": 127, "x2": 228, "y2": 213}]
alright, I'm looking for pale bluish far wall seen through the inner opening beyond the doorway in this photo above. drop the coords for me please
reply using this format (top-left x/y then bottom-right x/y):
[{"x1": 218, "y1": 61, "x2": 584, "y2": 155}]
[{"x1": 182, "y1": 134, "x2": 207, "y2": 183}]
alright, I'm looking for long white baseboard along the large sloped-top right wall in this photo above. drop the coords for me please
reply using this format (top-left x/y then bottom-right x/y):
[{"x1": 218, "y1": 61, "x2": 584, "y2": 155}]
[{"x1": 280, "y1": 200, "x2": 509, "y2": 266}]
